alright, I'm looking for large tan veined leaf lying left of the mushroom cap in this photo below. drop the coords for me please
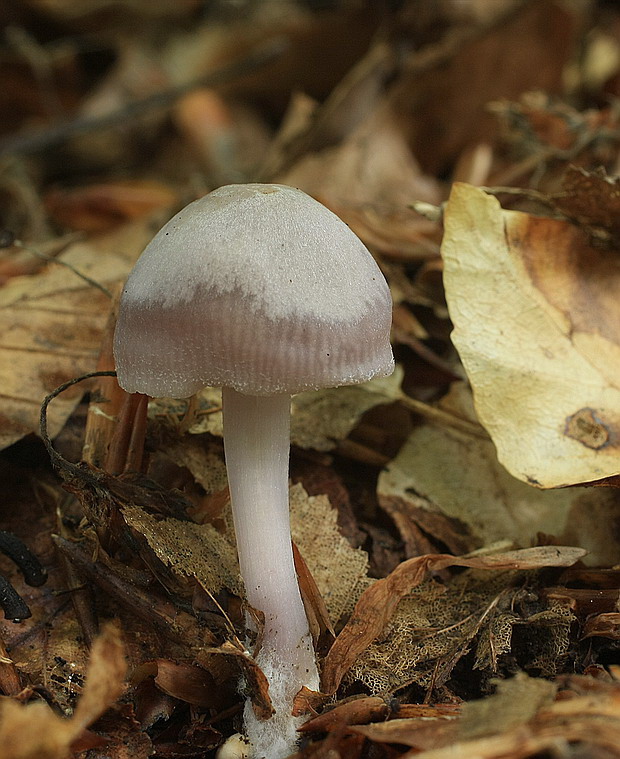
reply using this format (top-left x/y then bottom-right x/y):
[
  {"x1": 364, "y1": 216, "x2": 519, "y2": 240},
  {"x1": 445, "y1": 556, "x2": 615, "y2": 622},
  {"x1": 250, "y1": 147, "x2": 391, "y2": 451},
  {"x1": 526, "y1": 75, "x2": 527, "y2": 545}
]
[{"x1": 0, "y1": 217, "x2": 157, "y2": 448}]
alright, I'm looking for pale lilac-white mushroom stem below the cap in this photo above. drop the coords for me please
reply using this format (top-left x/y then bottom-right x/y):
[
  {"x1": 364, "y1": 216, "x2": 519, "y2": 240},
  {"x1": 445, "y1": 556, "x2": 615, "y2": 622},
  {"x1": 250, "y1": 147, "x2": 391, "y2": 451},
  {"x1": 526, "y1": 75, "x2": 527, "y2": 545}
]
[{"x1": 222, "y1": 388, "x2": 318, "y2": 759}]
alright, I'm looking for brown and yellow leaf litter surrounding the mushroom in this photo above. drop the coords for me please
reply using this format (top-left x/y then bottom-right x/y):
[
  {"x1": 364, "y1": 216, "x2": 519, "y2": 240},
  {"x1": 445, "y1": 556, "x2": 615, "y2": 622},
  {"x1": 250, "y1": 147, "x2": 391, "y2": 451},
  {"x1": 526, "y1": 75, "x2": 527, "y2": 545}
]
[{"x1": 0, "y1": 0, "x2": 620, "y2": 759}]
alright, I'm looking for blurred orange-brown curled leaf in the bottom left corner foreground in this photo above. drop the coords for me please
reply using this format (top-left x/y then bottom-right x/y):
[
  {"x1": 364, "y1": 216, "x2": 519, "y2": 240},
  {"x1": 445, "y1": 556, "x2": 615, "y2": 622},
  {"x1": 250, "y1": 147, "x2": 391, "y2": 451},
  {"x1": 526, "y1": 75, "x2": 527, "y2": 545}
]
[{"x1": 0, "y1": 625, "x2": 126, "y2": 759}]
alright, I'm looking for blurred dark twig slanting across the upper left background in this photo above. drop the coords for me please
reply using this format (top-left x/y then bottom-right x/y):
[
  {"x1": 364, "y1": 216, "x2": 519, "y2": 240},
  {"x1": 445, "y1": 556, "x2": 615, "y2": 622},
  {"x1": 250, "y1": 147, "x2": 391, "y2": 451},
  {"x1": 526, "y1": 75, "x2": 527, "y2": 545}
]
[{"x1": 0, "y1": 38, "x2": 288, "y2": 156}]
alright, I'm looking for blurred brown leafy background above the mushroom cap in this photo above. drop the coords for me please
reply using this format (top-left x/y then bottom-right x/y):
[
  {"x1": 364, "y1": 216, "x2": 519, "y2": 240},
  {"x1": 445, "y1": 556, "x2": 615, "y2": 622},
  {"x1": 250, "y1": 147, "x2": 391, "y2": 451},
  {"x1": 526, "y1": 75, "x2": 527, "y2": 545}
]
[{"x1": 0, "y1": 0, "x2": 620, "y2": 246}]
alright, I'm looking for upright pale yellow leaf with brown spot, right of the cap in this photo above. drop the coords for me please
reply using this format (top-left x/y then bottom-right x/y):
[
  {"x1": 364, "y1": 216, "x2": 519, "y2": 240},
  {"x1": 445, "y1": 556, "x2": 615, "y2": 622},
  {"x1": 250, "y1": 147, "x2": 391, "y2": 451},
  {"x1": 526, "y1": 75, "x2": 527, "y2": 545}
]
[{"x1": 442, "y1": 184, "x2": 620, "y2": 488}]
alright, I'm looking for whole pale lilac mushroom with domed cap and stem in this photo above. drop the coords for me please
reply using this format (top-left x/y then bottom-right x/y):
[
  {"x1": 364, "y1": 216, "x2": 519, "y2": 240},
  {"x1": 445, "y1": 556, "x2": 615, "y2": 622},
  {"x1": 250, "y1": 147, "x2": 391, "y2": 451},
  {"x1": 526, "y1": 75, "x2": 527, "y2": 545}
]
[{"x1": 114, "y1": 184, "x2": 394, "y2": 759}]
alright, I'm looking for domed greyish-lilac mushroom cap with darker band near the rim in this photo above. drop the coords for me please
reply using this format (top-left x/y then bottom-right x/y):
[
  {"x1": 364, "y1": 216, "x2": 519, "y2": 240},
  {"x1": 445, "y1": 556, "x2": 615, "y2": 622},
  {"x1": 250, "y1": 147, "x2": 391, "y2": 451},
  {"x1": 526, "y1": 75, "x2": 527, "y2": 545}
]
[{"x1": 114, "y1": 184, "x2": 394, "y2": 398}]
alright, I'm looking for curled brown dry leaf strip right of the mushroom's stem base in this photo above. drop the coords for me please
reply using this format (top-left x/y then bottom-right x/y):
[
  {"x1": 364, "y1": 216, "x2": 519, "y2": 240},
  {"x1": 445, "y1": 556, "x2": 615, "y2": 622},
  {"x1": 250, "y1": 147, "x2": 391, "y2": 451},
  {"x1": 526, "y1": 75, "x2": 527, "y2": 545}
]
[{"x1": 321, "y1": 546, "x2": 585, "y2": 693}]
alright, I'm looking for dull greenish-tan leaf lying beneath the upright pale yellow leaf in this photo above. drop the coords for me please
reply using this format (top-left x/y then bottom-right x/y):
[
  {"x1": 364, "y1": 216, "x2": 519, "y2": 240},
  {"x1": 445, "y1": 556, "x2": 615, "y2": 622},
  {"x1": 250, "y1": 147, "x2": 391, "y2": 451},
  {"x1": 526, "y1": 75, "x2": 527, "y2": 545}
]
[{"x1": 377, "y1": 383, "x2": 620, "y2": 566}]
